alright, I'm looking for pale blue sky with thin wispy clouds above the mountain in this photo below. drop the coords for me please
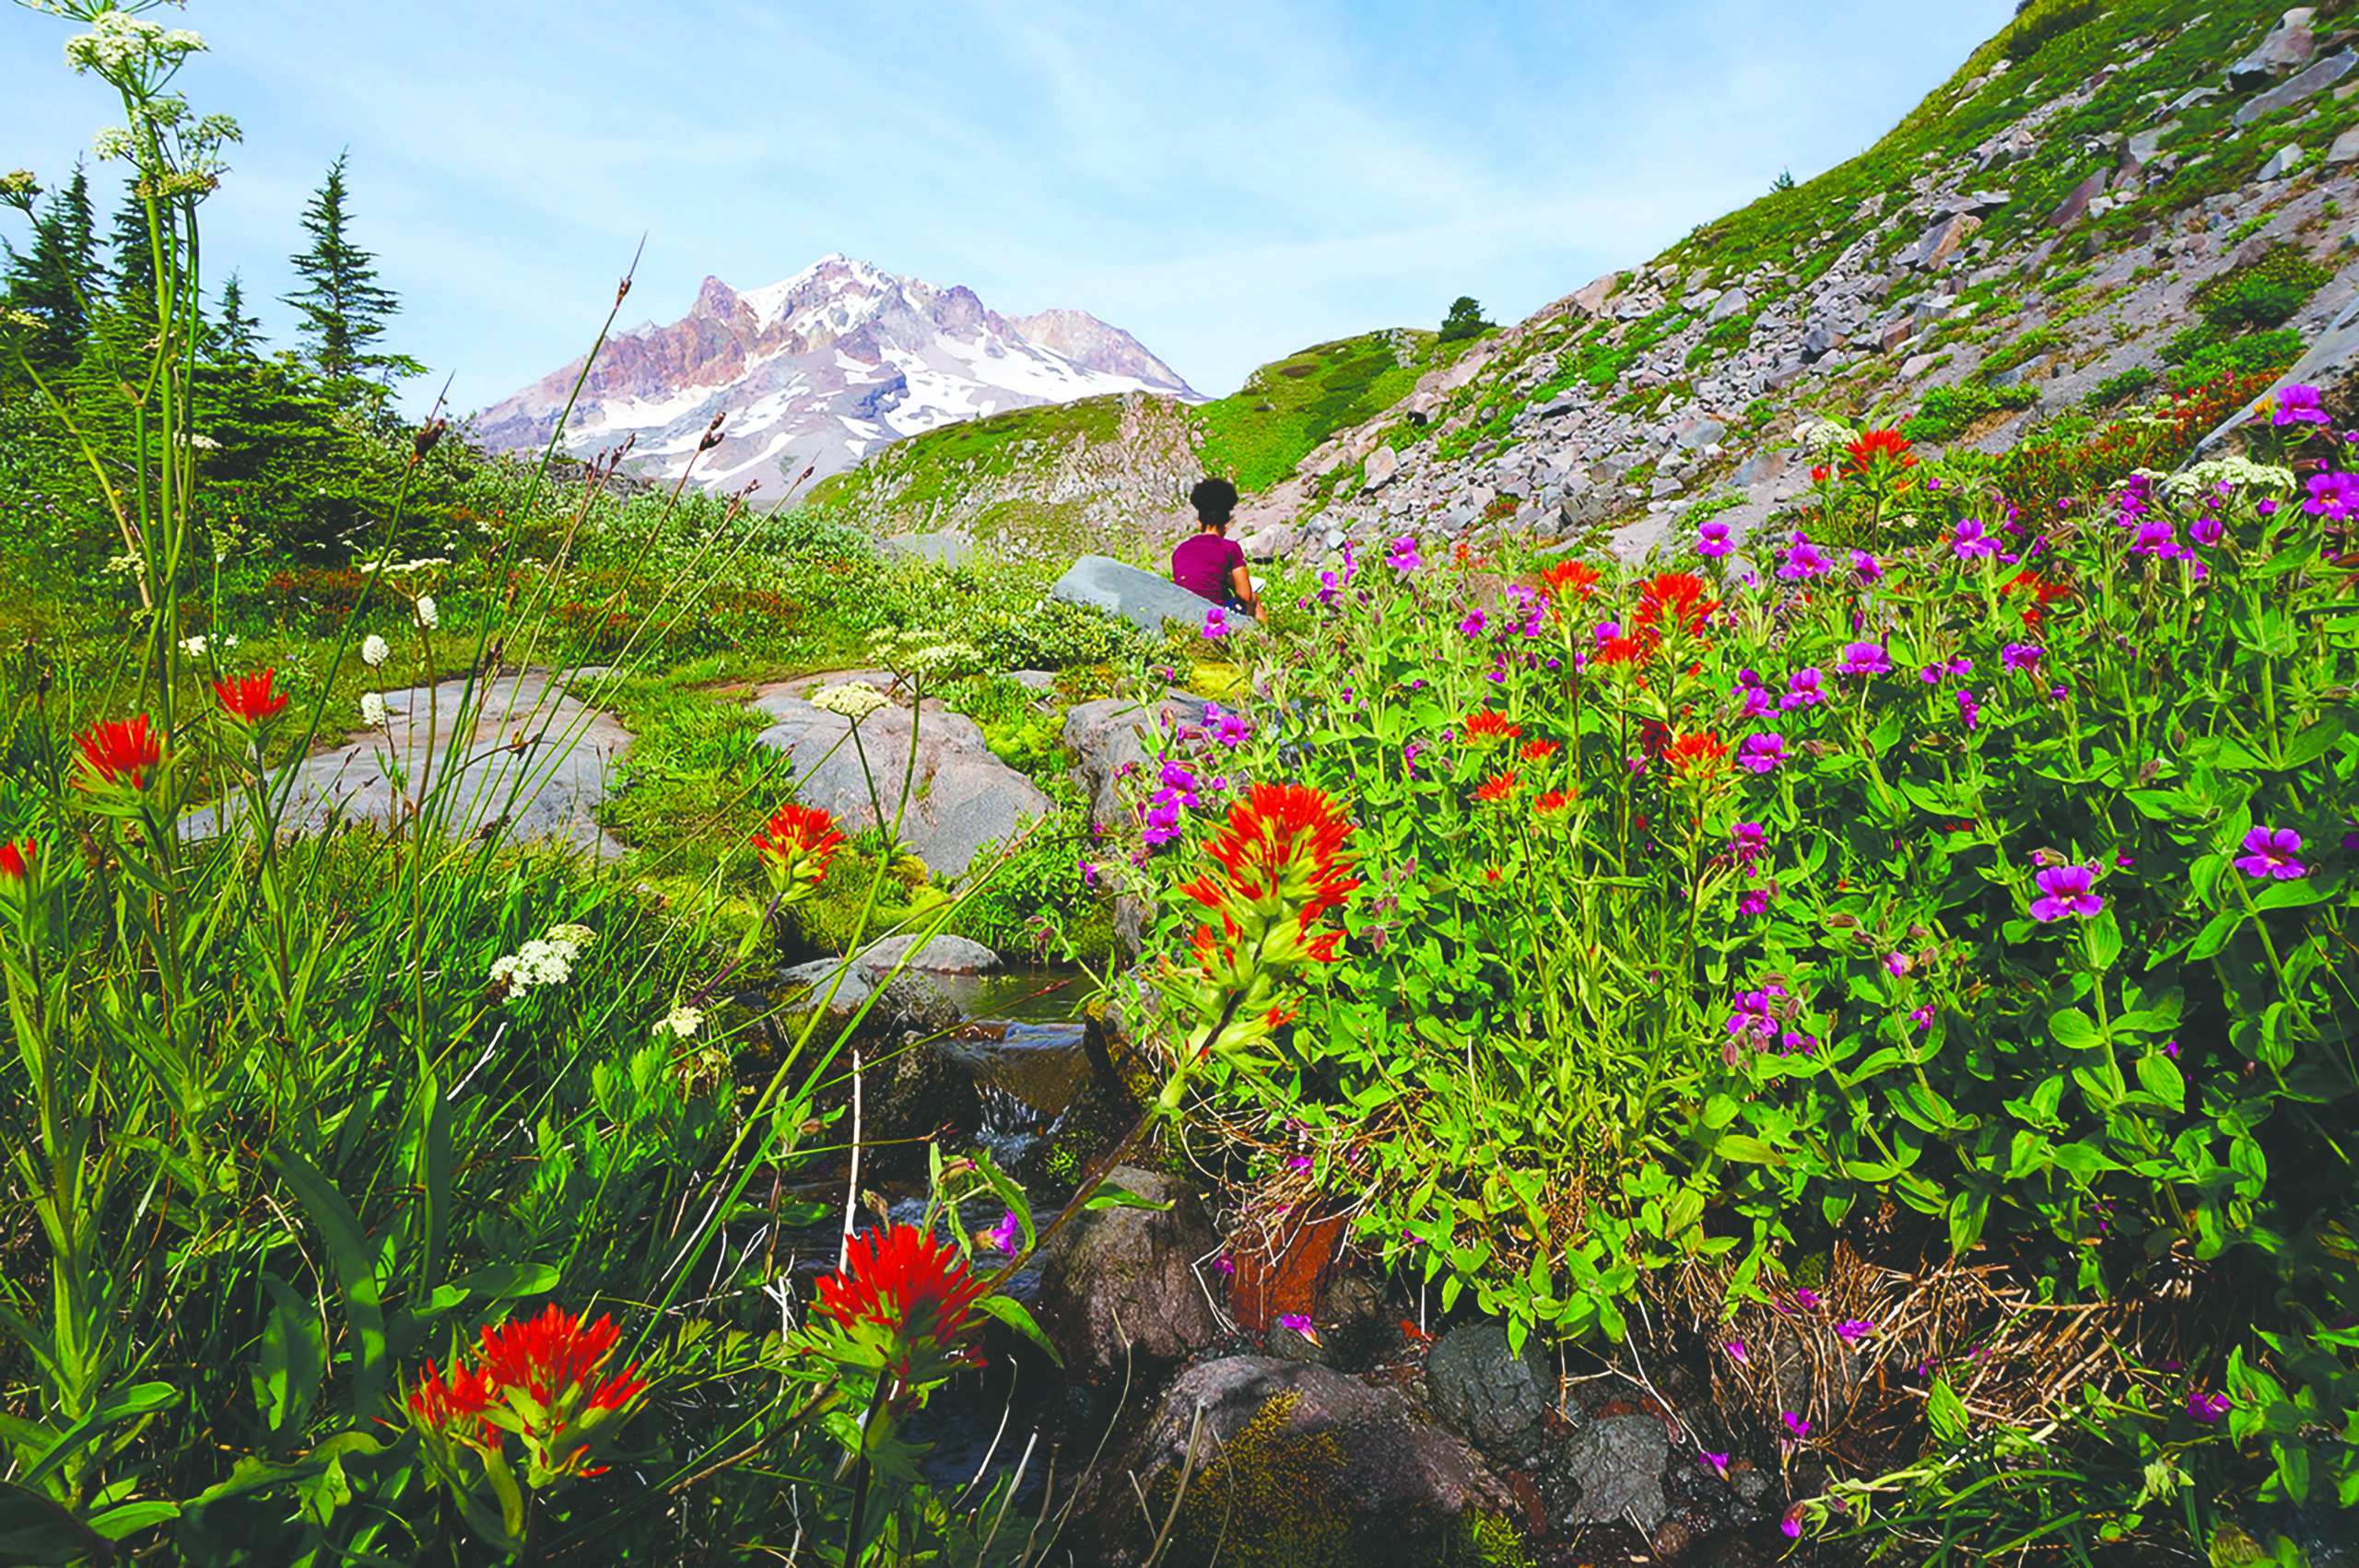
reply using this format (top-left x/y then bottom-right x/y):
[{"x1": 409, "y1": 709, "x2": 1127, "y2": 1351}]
[{"x1": 0, "y1": 0, "x2": 2014, "y2": 410}]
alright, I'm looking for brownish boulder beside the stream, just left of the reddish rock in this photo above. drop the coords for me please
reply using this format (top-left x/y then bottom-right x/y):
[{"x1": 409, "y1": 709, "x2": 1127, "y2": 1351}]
[{"x1": 1033, "y1": 1164, "x2": 1222, "y2": 1387}]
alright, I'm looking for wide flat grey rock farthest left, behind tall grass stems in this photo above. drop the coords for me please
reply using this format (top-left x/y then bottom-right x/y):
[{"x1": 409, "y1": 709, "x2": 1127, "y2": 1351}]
[{"x1": 186, "y1": 670, "x2": 630, "y2": 859}]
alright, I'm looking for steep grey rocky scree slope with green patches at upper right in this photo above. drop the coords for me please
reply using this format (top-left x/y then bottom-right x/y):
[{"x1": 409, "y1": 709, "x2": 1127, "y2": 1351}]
[{"x1": 1283, "y1": 0, "x2": 2359, "y2": 559}]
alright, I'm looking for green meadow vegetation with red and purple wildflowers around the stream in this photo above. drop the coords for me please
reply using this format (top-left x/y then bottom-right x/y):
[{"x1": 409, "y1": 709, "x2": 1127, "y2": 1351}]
[{"x1": 0, "y1": 0, "x2": 2359, "y2": 1568}]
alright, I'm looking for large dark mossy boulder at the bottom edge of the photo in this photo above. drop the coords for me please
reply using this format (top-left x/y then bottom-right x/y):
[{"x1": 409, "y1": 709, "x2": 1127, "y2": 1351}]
[{"x1": 1080, "y1": 1356, "x2": 1517, "y2": 1568}]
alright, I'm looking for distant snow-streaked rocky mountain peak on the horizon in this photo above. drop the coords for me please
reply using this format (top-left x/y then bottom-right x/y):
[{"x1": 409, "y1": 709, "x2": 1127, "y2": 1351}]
[{"x1": 476, "y1": 254, "x2": 1193, "y2": 505}]
